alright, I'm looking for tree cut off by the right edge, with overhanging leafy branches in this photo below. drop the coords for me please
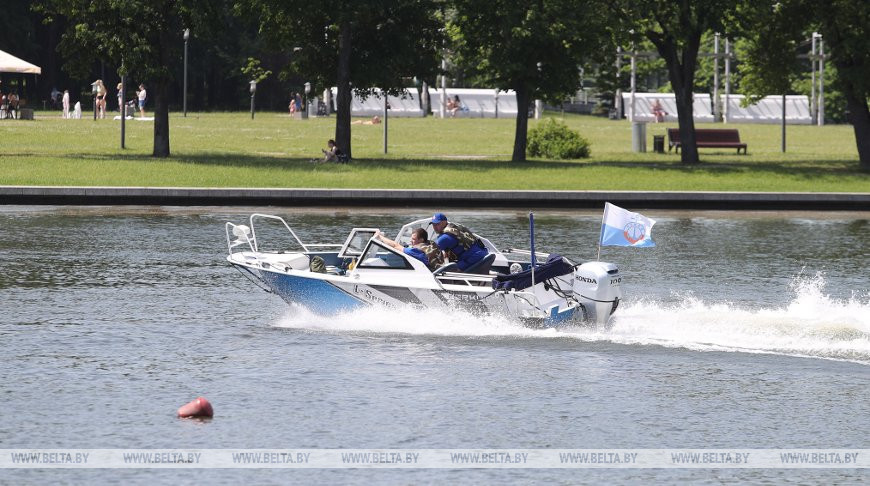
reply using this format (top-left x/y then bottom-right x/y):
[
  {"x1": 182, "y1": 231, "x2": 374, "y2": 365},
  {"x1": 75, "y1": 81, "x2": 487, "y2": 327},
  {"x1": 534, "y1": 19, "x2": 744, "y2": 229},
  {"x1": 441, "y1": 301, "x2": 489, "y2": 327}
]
[{"x1": 742, "y1": 0, "x2": 870, "y2": 171}]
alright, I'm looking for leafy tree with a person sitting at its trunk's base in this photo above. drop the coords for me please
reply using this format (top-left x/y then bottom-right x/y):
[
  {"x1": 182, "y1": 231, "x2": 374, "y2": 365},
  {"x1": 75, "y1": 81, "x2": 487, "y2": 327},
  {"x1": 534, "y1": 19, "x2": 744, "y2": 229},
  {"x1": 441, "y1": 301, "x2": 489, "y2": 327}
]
[{"x1": 244, "y1": 0, "x2": 443, "y2": 156}]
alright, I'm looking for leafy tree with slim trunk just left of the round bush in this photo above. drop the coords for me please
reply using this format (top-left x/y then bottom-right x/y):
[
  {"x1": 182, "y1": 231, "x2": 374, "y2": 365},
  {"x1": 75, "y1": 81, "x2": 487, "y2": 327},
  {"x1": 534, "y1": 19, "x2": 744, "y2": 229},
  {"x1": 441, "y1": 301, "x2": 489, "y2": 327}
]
[{"x1": 448, "y1": 0, "x2": 607, "y2": 161}]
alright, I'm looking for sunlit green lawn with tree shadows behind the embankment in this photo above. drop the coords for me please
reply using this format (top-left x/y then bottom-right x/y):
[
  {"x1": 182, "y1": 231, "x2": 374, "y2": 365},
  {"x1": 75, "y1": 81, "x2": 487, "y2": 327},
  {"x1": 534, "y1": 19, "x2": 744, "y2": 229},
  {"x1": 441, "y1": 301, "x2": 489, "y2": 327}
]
[{"x1": 0, "y1": 112, "x2": 870, "y2": 192}]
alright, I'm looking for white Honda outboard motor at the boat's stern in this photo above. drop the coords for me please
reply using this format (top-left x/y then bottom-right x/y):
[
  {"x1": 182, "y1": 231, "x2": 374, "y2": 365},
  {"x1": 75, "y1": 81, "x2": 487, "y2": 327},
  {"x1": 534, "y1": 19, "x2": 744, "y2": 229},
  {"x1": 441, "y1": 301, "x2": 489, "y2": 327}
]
[{"x1": 574, "y1": 262, "x2": 622, "y2": 329}]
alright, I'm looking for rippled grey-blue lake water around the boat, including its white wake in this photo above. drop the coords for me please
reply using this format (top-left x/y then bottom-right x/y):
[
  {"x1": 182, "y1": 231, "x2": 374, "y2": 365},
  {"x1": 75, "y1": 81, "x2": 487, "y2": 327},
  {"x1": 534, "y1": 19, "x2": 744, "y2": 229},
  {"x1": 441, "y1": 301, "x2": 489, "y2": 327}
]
[{"x1": 0, "y1": 206, "x2": 870, "y2": 484}]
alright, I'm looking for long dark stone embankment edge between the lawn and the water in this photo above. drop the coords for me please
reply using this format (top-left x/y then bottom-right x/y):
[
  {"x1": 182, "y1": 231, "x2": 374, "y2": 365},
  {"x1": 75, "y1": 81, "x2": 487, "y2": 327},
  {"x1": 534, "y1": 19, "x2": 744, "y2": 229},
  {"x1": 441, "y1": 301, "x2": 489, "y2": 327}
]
[{"x1": 0, "y1": 186, "x2": 870, "y2": 211}]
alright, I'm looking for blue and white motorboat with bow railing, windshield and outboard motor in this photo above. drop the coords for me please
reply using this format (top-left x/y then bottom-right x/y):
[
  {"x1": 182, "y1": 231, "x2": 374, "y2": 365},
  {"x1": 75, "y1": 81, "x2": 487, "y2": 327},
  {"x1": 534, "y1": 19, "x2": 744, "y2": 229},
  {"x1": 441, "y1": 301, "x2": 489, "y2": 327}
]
[{"x1": 226, "y1": 214, "x2": 622, "y2": 329}]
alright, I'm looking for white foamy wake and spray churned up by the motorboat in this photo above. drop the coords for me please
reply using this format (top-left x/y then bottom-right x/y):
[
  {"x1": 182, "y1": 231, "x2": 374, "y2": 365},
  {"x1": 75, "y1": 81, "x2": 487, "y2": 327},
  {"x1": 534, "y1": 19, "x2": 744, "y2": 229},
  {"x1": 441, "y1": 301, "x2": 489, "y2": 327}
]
[{"x1": 275, "y1": 275, "x2": 870, "y2": 365}]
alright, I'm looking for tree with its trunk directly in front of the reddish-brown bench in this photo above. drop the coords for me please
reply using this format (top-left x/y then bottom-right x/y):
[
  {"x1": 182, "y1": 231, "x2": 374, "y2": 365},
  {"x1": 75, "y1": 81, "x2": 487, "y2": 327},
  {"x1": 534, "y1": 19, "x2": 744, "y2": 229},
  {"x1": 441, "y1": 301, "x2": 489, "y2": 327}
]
[{"x1": 612, "y1": 0, "x2": 742, "y2": 164}]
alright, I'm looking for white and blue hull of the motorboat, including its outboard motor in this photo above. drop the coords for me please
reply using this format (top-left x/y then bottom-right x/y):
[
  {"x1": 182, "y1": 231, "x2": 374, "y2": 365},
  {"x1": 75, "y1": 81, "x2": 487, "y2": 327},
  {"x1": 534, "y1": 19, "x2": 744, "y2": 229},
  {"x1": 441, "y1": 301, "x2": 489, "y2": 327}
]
[{"x1": 227, "y1": 216, "x2": 621, "y2": 328}]
